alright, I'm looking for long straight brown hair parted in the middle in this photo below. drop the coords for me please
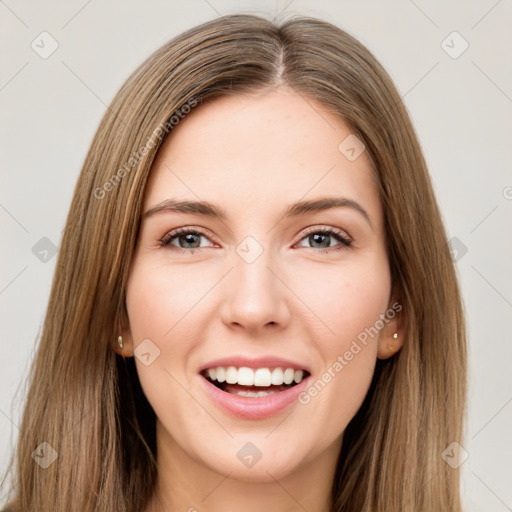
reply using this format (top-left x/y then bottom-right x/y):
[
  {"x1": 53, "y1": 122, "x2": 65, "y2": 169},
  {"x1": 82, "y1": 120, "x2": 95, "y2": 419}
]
[{"x1": 1, "y1": 15, "x2": 466, "y2": 512}]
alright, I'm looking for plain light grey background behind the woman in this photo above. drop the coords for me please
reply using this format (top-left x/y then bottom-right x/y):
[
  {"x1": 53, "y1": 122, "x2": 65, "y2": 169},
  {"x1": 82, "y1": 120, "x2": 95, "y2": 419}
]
[{"x1": 0, "y1": 0, "x2": 512, "y2": 512}]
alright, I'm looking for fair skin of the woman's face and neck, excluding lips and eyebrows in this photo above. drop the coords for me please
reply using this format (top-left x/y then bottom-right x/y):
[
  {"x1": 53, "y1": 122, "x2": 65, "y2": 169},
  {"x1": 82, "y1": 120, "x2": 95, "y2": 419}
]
[{"x1": 118, "y1": 86, "x2": 405, "y2": 512}]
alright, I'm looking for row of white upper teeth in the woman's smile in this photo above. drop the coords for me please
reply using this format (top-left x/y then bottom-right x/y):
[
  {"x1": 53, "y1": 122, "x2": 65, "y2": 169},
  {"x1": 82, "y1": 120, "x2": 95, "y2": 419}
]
[{"x1": 207, "y1": 366, "x2": 304, "y2": 386}]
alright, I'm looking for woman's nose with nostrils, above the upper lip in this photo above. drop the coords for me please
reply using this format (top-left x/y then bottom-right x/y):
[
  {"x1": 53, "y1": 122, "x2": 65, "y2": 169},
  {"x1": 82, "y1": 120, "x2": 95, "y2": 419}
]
[{"x1": 221, "y1": 245, "x2": 292, "y2": 334}]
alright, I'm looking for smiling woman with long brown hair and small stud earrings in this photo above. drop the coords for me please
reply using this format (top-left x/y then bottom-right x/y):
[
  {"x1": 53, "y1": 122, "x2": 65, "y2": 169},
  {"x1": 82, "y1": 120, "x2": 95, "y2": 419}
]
[{"x1": 0, "y1": 15, "x2": 466, "y2": 512}]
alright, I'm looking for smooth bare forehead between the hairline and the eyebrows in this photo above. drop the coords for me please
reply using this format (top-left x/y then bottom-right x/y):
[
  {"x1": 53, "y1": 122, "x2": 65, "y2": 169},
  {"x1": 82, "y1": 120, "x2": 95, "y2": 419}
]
[{"x1": 145, "y1": 86, "x2": 380, "y2": 228}]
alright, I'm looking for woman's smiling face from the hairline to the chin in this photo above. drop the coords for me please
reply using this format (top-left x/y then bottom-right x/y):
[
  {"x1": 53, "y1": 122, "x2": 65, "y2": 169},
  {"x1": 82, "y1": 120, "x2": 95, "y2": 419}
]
[{"x1": 125, "y1": 87, "x2": 396, "y2": 481}]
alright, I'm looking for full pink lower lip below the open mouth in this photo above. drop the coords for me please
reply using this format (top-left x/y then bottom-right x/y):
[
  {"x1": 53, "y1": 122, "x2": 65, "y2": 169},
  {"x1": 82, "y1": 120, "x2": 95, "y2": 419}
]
[{"x1": 199, "y1": 375, "x2": 309, "y2": 420}]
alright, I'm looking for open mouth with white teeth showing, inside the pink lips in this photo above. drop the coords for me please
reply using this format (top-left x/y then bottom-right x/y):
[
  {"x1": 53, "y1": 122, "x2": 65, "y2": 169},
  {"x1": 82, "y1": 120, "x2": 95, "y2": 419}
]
[{"x1": 200, "y1": 366, "x2": 310, "y2": 398}]
